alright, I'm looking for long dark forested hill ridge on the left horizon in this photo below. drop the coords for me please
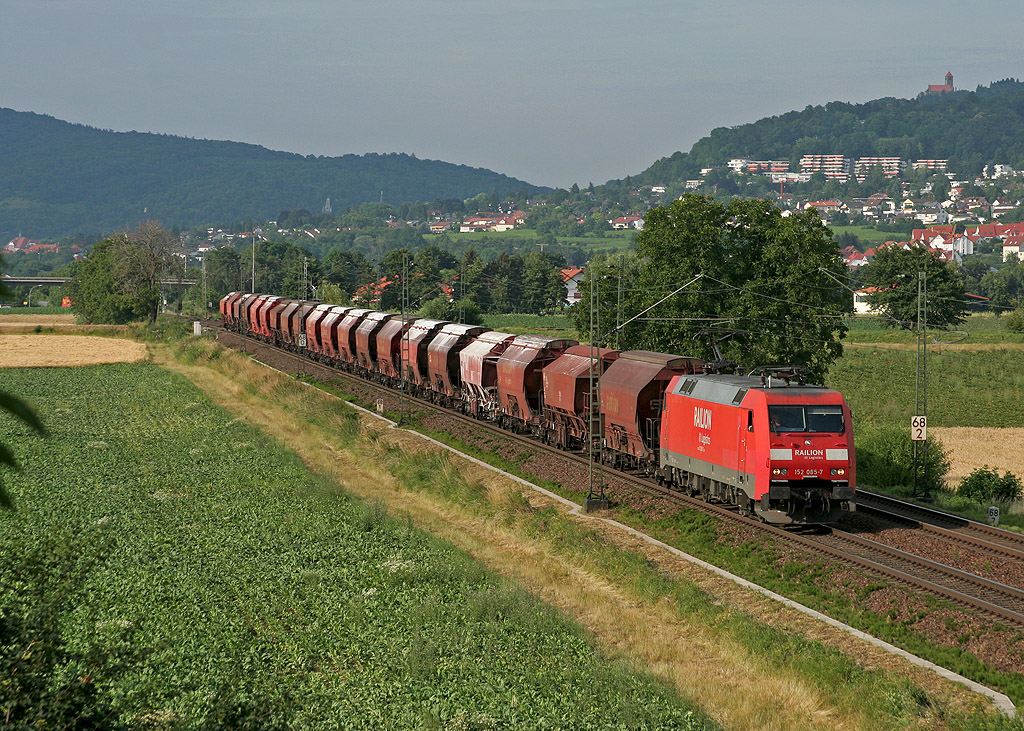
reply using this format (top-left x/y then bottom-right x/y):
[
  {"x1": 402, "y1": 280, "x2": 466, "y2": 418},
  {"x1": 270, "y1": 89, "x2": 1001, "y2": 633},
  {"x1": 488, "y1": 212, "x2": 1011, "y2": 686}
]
[{"x1": 0, "y1": 109, "x2": 546, "y2": 236}]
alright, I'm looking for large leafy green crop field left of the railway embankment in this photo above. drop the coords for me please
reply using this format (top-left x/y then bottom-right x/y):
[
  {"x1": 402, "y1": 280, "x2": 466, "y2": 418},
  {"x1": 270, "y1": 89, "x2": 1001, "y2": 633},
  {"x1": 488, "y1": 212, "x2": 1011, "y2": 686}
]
[{"x1": 0, "y1": 363, "x2": 709, "y2": 729}]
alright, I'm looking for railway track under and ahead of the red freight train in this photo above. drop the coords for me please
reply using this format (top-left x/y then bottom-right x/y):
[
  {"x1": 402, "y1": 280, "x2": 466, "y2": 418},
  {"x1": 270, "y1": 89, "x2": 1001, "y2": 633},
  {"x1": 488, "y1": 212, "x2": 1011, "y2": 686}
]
[{"x1": 206, "y1": 320, "x2": 1024, "y2": 630}]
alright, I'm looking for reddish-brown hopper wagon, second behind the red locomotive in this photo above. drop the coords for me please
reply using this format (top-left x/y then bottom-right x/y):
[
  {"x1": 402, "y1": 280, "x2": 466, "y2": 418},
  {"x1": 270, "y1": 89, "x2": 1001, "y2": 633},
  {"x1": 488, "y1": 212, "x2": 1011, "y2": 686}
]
[{"x1": 544, "y1": 345, "x2": 618, "y2": 449}]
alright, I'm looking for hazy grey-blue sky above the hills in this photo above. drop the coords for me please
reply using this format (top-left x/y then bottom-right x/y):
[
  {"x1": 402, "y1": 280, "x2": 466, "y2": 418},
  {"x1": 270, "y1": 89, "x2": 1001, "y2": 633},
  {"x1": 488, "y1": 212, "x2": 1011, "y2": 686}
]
[{"x1": 0, "y1": 0, "x2": 1024, "y2": 187}]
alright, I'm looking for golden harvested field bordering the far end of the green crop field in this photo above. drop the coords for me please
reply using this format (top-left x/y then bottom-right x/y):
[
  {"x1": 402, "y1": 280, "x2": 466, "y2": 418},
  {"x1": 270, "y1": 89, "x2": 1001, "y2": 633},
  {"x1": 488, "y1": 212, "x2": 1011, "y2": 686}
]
[{"x1": 0, "y1": 335, "x2": 146, "y2": 368}]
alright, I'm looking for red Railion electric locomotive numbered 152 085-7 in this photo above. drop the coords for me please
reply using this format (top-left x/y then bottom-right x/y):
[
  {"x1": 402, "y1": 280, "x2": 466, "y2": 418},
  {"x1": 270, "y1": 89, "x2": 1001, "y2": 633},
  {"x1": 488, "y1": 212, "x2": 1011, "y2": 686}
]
[{"x1": 659, "y1": 375, "x2": 856, "y2": 524}]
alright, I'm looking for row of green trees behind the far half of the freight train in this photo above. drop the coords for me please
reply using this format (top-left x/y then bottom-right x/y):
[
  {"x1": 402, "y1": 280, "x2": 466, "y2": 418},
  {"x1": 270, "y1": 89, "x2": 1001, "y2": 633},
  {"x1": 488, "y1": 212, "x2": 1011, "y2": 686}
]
[{"x1": 65, "y1": 221, "x2": 566, "y2": 323}]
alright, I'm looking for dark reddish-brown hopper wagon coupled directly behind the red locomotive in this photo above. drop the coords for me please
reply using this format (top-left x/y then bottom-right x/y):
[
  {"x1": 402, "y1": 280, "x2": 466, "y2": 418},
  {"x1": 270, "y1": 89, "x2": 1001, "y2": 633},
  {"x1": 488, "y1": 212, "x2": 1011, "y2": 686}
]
[{"x1": 601, "y1": 350, "x2": 705, "y2": 470}]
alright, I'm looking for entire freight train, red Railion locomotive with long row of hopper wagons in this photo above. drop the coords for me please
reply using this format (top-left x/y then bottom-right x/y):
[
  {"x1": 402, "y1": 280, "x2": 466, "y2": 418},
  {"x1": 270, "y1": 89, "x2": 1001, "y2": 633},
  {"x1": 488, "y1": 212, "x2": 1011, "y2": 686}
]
[{"x1": 220, "y1": 292, "x2": 856, "y2": 525}]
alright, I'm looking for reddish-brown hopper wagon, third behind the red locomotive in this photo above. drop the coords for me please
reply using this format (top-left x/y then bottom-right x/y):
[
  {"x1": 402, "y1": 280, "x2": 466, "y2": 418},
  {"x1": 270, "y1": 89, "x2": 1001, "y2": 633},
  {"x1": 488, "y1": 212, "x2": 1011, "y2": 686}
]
[{"x1": 498, "y1": 335, "x2": 579, "y2": 433}]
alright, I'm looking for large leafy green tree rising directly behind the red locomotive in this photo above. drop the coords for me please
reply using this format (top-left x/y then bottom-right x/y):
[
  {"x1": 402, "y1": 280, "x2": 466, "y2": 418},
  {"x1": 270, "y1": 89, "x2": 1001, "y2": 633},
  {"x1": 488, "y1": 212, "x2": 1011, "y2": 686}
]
[{"x1": 575, "y1": 195, "x2": 850, "y2": 379}]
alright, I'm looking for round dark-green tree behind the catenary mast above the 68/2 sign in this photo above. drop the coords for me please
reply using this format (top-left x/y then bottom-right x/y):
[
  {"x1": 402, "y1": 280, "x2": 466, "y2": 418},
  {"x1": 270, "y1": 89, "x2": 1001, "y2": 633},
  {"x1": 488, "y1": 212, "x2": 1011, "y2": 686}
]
[{"x1": 863, "y1": 246, "x2": 968, "y2": 330}]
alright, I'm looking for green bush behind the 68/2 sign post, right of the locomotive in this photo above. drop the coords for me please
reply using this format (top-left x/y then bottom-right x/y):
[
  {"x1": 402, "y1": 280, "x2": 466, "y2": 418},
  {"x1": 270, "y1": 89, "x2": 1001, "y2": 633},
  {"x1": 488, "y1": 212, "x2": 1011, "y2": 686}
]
[{"x1": 856, "y1": 425, "x2": 949, "y2": 492}]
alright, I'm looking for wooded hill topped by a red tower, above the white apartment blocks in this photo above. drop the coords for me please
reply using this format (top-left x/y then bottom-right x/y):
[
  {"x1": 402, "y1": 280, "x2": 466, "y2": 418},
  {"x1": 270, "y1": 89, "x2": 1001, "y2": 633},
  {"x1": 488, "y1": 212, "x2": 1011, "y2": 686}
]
[{"x1": 634, "y1": 79, "x2": 1024, "y2": 184}]
